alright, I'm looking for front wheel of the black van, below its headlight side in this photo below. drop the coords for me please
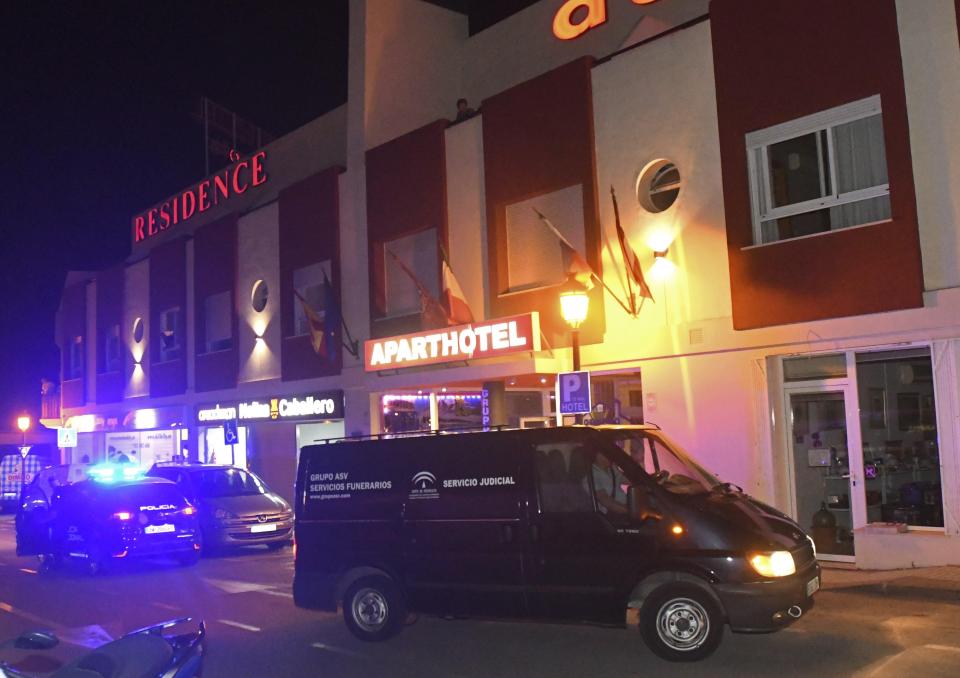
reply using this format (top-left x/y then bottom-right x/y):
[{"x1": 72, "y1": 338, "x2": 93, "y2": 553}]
[{"x1": 640, "y1": 583, "x2": 724, "y2": 662}]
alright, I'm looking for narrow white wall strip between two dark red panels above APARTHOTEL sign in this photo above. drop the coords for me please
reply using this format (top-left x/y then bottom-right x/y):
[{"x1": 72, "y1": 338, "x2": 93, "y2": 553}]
[{"x1": 446, "y1": 116, "x2": 488, "y2": 320}]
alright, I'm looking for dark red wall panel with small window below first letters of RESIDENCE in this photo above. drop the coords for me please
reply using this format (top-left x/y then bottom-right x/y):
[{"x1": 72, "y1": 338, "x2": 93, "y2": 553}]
[{"x1": 149, "y1": 238, "x2": 190, "y2": 398}]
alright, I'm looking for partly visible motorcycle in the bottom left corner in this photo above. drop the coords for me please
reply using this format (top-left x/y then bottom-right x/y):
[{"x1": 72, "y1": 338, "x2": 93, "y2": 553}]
[{"x1": 0, "y1": 617, "x2": 207, "y2": 678}]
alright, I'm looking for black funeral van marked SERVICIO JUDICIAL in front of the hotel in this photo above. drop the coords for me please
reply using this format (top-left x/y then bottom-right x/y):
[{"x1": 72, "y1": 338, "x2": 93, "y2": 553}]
[{"x1": 293, "y1": 426, "x2": 820, "y2": 661}]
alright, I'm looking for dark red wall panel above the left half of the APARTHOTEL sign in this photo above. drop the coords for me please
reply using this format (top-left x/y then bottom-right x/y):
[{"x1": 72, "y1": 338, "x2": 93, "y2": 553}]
[{"x1": 366, "y1": 120, "x2": 449, "y2": 337}]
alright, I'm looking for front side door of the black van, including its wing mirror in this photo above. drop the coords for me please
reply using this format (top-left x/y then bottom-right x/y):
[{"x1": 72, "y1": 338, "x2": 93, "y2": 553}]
[{"x1": 528, "y1": 438, "x2": 657, "y2": 623}]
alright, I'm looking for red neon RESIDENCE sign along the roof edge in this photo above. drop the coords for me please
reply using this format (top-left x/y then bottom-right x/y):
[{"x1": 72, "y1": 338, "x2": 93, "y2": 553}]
[{"x1": 133, "y1": 151, "x2": 267, "y2": 244}]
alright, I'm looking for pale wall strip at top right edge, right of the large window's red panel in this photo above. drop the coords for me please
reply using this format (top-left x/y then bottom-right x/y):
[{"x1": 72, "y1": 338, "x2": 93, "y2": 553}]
[{"x1": 897, "y1": 0, "x2": 960, "y2": 290}]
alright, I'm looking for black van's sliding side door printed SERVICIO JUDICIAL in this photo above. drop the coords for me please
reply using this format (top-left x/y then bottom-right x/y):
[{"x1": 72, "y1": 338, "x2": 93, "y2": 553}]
[{"x1": 403, "y1": 433, "x2": 526, "y2": 617}]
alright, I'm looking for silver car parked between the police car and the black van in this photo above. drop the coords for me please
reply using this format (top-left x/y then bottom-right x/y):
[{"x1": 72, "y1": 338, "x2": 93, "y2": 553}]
[{"x1": 147, "y1": 463, "x2": 293, "y2": 553}]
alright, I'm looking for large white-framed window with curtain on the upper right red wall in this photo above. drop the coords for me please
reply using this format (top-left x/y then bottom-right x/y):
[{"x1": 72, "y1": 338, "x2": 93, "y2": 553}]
[{"x1": 746, "y1": 96, "x2": 890, "y2": 245}]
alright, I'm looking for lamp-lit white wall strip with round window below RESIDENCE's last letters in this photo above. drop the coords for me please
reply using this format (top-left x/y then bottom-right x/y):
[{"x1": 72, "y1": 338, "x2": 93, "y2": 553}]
[{"x1": 234, "y1": 202, "x2": 283, "y2": 382}]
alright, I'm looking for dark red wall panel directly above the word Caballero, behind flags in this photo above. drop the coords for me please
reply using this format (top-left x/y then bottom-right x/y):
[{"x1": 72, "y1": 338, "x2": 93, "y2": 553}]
[{"x1": 279, "y1": 167, "x2": 343, "y2": 381}]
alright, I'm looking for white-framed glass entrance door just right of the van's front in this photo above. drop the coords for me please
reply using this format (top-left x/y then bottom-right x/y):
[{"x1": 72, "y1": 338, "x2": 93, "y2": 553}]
[{"x1": 786, "y1": 384, "x2": 865, "y2": 561}]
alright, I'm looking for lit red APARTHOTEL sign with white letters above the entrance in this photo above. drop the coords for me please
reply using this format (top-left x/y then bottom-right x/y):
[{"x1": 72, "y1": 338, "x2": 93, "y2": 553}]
[{"x1": 363, "y1": 312, "x2": 540, "y2": 372}]
